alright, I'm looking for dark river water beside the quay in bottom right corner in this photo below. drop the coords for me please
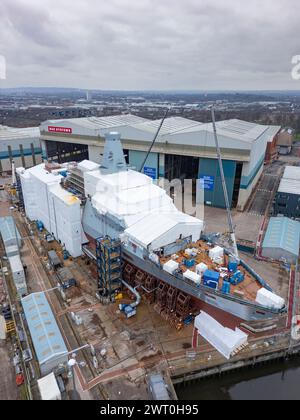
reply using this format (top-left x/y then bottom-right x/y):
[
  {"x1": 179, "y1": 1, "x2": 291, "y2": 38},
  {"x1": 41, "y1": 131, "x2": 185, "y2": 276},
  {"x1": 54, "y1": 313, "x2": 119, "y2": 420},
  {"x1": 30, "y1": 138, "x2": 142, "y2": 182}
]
[{"x1": 177, "y1": 359, "x2": 300, "y2": 400}]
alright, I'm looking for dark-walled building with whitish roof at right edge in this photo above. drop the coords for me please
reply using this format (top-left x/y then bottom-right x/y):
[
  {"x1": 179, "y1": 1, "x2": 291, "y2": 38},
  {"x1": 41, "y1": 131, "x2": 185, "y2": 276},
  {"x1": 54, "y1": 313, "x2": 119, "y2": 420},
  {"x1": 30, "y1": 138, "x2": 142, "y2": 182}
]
[{"x1": 274, "y1": 166, "x2": 300, "y2": 219}]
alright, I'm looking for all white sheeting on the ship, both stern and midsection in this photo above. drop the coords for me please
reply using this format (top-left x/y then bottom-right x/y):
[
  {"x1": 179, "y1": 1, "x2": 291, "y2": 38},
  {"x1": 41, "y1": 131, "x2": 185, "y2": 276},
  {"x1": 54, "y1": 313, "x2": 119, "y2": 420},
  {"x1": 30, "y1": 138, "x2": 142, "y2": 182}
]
[{"x1": 17, "y1": 161, "x2": 203, "y2": 258}]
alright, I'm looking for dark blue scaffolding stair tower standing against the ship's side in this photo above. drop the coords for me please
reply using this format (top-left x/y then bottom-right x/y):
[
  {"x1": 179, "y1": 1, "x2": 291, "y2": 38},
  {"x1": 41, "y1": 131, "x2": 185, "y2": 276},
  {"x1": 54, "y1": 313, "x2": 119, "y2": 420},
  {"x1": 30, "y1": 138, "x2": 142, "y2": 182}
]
[{"x1": 96, "y1": 236, "x2": 121, "y2": 299}]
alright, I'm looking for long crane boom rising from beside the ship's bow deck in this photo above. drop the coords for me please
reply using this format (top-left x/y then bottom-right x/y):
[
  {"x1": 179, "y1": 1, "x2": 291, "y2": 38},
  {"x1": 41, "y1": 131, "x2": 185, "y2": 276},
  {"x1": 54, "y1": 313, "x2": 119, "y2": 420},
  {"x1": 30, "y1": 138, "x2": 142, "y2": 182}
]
[{"x1": 211, "y1": 106, "x2": 239, "y2": 259}]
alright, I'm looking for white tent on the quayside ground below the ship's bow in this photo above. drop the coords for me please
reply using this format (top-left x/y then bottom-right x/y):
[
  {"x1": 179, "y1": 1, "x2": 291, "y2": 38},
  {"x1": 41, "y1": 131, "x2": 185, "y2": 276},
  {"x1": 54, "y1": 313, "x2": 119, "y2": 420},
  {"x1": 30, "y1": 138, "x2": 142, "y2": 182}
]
[{"x1": 195, "y1": 312, "x2": 248, "y2": 360}]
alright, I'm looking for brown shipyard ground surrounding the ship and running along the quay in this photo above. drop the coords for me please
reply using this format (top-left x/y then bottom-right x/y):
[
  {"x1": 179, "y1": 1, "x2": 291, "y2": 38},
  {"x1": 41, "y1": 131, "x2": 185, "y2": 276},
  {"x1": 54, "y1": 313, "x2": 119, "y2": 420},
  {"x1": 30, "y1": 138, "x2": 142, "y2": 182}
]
[{"x1": 0, "y1": 165, "x2": 299, "y2": 400}]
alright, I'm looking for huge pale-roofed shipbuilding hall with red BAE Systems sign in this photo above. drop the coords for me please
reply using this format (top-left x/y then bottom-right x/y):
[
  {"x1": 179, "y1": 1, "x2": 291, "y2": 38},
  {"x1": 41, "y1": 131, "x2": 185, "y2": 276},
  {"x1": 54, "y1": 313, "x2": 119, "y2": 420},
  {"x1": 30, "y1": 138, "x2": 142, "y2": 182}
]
[{"x1": 40, "y1": 115, "x2": 280, "y2": 210}]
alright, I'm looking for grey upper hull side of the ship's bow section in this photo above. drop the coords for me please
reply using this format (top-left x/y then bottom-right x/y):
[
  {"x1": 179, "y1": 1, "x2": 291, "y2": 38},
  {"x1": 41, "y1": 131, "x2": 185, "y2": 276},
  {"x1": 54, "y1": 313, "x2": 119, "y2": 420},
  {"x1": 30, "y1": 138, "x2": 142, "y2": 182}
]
[{"x1": 122, "y1": 247, "x2": 280, "y2": 322}]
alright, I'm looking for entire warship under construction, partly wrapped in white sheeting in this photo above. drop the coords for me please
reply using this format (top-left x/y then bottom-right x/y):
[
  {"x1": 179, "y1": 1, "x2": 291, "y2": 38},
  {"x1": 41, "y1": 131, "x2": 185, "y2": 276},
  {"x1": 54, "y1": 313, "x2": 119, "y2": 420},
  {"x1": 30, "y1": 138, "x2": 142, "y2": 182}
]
[{"x1": 17, "y1": 133, "x2": 285, "y2": 320}]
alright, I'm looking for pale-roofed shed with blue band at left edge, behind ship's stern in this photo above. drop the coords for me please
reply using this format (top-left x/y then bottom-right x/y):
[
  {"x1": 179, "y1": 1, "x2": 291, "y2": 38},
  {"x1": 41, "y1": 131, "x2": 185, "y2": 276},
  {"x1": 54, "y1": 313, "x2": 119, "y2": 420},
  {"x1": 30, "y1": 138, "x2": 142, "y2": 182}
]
[{"x1": 0, "y1": 125, "x2": 42, "y2": 173}]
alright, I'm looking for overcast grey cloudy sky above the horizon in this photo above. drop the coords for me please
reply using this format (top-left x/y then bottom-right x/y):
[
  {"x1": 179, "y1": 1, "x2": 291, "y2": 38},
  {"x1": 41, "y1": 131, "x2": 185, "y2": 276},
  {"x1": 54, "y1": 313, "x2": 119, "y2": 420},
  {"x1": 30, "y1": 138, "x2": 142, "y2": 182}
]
[{"x1": 0, "y1": 0, "x2": 300, "y2": 90}]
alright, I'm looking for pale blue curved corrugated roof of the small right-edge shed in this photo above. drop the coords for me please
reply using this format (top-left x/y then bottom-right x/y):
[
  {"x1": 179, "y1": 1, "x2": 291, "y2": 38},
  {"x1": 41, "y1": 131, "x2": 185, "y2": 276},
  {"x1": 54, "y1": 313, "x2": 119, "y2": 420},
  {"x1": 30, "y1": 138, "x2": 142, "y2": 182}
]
[{"x1": 263, "y1": 217, "x2": 300, "y2": 256}]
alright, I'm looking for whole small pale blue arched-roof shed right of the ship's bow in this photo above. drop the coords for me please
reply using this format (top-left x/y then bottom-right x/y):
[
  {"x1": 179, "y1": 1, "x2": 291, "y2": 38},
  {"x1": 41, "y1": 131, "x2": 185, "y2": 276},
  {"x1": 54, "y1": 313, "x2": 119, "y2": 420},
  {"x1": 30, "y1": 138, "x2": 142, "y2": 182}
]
[{"x1": 262, "y1": 217, "x2": 300, "y2": 264}]
